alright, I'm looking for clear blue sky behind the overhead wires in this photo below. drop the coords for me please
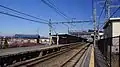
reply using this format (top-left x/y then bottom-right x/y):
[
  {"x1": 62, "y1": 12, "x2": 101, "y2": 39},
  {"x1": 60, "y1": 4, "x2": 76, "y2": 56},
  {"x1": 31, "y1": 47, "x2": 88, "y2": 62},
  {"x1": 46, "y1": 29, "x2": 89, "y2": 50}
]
[{"x1": 0, "y1": 0, "x2": 119, "y2": 36}]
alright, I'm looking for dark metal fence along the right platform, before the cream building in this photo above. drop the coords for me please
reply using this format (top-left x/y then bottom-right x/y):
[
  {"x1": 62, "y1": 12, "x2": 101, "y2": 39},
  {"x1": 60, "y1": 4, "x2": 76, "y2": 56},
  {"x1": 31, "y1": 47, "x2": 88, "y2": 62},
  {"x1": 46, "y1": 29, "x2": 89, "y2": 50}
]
[{"x1": 97, "y1": 36, "x2": 120, "y2": 67}]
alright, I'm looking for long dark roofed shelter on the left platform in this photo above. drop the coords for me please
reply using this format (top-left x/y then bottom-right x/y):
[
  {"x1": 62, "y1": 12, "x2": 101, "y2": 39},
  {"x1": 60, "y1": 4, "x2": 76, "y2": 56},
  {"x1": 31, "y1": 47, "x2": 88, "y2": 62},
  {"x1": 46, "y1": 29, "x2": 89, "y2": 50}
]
[{"x1": 52, "y1": 34, "x2": 87, "y2": 44}]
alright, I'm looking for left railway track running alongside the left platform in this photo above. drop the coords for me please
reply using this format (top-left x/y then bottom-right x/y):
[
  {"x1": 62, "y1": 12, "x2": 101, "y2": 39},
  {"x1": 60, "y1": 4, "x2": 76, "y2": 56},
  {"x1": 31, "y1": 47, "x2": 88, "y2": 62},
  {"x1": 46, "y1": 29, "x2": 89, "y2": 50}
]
[{"x1": 9, "y1": 44, "x2": 88, "y2": 67}]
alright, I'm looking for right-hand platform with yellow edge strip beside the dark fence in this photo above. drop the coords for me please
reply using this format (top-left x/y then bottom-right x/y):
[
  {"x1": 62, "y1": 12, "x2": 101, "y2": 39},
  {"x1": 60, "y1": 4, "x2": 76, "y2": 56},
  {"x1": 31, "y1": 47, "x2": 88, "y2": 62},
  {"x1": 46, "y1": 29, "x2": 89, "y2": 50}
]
[{"x1": 89, "y1": 46, "x2": 110, "y2": 67}]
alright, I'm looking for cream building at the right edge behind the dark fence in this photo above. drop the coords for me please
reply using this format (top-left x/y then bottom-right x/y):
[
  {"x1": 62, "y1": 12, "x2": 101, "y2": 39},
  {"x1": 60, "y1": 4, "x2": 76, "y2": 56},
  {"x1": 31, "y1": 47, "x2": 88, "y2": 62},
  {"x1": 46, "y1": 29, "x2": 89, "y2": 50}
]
[{"x1": 103, "y1": 18, "x2": 120, "y2": 52}]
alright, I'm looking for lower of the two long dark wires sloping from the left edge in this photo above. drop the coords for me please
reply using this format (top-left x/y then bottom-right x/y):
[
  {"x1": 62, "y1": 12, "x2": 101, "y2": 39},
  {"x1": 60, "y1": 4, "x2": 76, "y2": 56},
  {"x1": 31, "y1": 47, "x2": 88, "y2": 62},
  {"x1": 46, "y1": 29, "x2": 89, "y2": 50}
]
[{"x1": 0, "y1": 11, "x2": 48, "y2": 24}]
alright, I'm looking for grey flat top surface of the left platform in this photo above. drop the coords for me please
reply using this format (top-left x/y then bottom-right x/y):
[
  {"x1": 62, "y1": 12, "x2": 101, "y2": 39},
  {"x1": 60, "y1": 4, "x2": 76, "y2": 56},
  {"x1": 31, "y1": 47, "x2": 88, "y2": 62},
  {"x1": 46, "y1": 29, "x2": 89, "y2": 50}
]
[{"x1": 0, "y1": 45, "x2": 60, "y2": 56}]
